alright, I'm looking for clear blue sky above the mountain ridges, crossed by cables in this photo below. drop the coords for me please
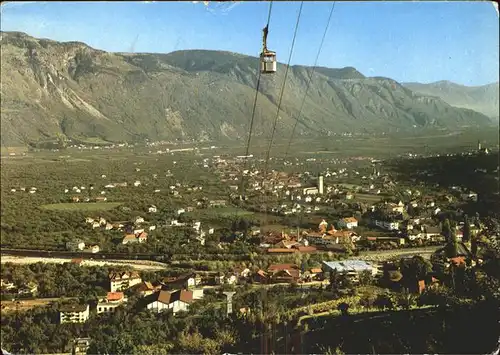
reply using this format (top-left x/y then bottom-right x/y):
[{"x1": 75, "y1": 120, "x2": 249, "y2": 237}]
[{"x1": 1, "y1": 1, "x2": 499, "y2": 85}]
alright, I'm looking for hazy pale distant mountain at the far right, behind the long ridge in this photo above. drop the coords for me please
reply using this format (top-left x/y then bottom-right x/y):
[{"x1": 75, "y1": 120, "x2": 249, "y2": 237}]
[{"x1": 403, "y1": 81, "x2": 499, "y2": 120}]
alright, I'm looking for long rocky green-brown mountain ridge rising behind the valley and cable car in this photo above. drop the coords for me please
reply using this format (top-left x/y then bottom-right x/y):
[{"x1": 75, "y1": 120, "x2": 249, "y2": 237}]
[{"x1": 0, "y1": 32, "x2": 491, "y2": 146}]
